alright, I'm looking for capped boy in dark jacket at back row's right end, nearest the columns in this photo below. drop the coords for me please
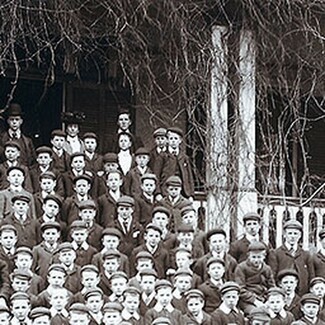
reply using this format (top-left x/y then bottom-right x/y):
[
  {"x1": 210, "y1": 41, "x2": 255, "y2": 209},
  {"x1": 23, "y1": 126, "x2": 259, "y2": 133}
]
[{"x1": 154, "y1": 127, "x2": 194, "y2": 200}]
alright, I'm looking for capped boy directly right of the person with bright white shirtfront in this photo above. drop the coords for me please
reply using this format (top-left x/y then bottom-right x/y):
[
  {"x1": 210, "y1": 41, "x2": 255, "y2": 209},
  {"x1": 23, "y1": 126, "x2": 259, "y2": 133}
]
[{"x1": 124, "y1": 148, "x2": 152, "y2": 196}]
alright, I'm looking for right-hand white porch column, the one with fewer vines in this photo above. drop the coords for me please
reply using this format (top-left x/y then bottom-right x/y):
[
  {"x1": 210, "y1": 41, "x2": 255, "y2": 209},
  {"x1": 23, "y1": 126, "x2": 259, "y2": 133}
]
[{"x1": 237, "y1": 30, "x2": 257, "y2": 235}]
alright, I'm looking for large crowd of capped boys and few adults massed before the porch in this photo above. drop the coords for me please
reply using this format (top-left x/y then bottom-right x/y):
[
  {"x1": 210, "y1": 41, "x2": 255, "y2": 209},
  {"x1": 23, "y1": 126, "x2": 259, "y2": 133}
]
[{"x1": 0, "y1": 104, "x2": 325, "y2": 325}]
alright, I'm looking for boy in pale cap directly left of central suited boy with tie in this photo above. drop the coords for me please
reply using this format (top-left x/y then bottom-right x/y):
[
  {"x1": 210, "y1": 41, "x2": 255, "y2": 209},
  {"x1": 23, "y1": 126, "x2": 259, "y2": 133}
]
[{"x1": 78, "y1": 200, "x2": 103, "y2": 250}]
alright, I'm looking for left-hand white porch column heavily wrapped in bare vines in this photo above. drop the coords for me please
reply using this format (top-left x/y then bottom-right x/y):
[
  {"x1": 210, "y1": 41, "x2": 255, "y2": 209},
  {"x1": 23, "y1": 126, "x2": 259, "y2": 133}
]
[{"x1": 206, "y1": 26, "x2": 230, "y2": 234}]
